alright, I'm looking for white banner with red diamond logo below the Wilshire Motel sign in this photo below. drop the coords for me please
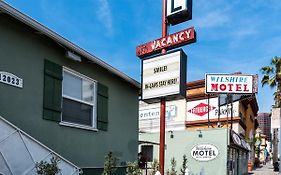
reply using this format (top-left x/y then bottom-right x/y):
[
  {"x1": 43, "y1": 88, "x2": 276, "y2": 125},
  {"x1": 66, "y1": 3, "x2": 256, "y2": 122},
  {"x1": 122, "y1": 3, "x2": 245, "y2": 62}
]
[{"x1": 186, "y1": 98, "x2": 239, "y2": 121}]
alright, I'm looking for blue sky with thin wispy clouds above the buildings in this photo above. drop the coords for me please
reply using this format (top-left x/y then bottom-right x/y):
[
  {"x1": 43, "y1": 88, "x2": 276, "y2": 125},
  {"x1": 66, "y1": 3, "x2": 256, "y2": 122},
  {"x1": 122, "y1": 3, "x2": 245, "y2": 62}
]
[{"x1": 5, "y1": 0, "x2": 281, "y2": 112}]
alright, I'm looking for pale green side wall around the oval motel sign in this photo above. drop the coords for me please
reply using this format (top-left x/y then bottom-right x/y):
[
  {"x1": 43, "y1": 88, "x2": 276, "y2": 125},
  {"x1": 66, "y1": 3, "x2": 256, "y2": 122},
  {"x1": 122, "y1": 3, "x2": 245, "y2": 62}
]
[{"x1": 139, "y1": 128, "x2": 229, "y2": 175}]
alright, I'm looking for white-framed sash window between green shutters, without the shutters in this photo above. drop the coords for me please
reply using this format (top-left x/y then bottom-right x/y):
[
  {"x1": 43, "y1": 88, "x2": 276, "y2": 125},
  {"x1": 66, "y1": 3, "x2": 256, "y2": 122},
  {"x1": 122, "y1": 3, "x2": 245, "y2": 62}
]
[{"x1": 62, "y1": 68, "x2": 97, "y2": 128}]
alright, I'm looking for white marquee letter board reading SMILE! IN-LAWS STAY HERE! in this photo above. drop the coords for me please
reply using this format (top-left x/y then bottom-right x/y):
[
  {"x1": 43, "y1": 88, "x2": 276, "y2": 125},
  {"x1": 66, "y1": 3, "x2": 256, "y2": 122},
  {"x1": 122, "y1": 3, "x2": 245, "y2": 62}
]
[{"x1": 142, "y1": 50, "x2": 186, "y2": 100}]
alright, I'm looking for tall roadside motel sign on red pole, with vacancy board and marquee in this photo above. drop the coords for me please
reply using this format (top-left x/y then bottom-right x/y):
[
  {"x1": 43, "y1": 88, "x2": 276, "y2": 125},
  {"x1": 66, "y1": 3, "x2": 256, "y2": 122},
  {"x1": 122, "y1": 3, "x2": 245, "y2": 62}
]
[{"x1": 136, "y1": 0, "x2": 196, "y2": 174}]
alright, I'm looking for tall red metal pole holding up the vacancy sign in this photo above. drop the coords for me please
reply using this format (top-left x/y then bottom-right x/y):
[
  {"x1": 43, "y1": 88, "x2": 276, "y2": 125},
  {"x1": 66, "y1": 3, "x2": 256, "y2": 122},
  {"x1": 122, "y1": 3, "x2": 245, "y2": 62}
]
[{"x1": 159, "y1": 0, "x2": 167, "y2": 175}]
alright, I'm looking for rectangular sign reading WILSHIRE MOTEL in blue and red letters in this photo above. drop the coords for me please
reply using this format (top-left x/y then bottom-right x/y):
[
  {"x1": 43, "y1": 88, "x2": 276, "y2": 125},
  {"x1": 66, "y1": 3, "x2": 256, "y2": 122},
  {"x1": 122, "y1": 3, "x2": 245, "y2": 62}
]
[{"x1": 205, "y1": 74, "x2": 256, "y2": 94}]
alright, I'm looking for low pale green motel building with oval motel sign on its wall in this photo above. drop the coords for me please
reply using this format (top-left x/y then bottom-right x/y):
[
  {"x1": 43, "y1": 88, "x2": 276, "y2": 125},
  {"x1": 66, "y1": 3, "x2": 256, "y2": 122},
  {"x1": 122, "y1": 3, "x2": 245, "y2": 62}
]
[{"x1": 139, "y1": 128, "x2": 250, "y2": 175}]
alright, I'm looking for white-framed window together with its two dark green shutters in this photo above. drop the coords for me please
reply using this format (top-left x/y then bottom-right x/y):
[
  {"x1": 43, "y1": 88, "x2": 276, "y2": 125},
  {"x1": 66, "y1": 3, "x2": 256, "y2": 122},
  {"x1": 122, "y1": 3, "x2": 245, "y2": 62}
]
[{"x1": 43, "y1": 60, "x2": 109, "y2": 131}]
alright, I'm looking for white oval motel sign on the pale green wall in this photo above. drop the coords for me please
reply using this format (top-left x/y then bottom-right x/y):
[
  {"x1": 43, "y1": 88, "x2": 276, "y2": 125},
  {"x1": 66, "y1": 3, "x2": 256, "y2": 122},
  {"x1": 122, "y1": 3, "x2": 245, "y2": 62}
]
[{"x1": 190, "y1": 144, "x2": 219, "y2": 162}]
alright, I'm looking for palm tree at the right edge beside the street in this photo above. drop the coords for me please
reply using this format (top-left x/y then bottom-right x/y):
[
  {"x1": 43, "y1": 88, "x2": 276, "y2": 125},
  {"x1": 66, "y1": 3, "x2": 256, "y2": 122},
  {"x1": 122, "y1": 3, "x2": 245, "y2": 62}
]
[{"x1": 261, "y1": 56, "x2": 281, "y2": 162}]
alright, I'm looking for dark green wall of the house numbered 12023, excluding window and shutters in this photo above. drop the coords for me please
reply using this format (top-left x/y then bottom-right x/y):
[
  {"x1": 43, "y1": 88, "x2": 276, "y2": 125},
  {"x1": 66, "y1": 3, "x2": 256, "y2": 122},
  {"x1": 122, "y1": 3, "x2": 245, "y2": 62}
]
[{"x1": 0, "y1": 13, "x2": 138, "y2": 167}]
